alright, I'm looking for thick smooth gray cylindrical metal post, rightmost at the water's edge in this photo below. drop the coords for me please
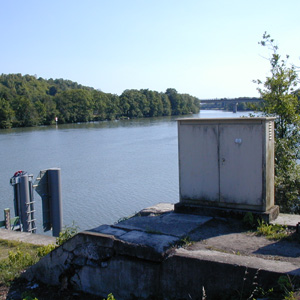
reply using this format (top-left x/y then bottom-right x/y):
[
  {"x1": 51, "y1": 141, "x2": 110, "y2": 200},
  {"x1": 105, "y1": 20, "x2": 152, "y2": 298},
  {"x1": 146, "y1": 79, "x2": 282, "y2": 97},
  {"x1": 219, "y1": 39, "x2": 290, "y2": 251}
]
[{"x1": 48, "y1": 168, "x2": 63, "y2": 237}]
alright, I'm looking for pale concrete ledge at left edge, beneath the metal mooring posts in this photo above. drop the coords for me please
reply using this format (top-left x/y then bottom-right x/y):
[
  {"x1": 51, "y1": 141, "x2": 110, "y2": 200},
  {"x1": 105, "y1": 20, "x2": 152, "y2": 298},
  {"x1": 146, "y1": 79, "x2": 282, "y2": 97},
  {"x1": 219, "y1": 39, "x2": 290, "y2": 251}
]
[{"x1": 0, "y1": 229, "x2": 56, "y2": 245}]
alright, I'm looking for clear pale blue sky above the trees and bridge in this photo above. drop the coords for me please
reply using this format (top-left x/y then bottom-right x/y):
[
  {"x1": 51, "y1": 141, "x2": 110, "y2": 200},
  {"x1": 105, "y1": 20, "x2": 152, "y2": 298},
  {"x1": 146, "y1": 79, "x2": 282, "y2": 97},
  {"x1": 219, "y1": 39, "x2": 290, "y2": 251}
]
[{"x1": 0, "y1": 0, "x2": 300, "y2": 99}]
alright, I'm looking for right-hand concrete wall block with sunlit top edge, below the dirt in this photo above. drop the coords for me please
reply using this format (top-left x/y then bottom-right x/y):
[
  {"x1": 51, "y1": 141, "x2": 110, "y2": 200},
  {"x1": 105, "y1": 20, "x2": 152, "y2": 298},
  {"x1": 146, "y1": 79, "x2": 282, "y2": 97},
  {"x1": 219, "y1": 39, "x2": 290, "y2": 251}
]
[{"x1": 160, "y1": 249, "x2": 292, "y2": 299}]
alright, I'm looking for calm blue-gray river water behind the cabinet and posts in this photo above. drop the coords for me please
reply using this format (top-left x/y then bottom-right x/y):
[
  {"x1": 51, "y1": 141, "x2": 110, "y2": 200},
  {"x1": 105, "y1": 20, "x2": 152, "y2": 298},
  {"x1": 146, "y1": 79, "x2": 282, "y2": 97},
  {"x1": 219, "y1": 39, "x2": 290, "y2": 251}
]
[{"x1": 0, "y1": 110, "x2": 249, "y2": 234}]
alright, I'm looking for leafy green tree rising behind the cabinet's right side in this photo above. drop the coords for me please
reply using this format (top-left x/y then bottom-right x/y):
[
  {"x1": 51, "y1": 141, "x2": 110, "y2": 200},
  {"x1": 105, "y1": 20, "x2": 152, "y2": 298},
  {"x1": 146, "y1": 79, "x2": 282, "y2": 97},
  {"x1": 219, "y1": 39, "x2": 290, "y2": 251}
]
[{"x1": 255, "y1": 33, "x2": 300, "y2": 213}]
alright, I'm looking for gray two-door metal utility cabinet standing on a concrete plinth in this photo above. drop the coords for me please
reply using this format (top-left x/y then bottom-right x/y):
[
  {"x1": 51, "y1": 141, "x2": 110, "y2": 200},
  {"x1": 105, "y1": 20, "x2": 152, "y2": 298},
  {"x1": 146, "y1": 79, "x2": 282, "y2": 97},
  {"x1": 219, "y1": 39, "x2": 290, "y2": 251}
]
[{"x1": 178, "y1": 118, "x2": 274, "y2": 211}]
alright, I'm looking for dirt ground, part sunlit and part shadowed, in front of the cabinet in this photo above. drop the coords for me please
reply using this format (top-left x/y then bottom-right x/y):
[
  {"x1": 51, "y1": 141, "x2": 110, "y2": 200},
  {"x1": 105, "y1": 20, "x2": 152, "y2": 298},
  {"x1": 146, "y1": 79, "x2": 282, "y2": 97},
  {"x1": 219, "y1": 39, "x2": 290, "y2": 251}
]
[{"x1": 188, "y1": 218, "x2": 300, "y2": 263}]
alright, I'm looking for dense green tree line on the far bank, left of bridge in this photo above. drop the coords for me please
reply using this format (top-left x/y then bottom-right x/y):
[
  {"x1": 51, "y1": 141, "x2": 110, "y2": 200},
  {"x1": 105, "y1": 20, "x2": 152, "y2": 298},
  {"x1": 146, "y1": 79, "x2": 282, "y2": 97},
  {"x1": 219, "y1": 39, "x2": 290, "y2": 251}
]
[{"x1": 0, "y1": 74, "x2": 200, "y2": 128}]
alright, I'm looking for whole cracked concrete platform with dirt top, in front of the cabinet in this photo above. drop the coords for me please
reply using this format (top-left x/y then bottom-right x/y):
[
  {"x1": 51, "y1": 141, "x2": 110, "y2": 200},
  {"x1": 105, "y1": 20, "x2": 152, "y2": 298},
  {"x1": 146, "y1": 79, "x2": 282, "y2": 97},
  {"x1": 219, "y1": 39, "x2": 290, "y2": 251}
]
[{"x1": 21, "y1": 204, "x2": 300, "y2": 300}]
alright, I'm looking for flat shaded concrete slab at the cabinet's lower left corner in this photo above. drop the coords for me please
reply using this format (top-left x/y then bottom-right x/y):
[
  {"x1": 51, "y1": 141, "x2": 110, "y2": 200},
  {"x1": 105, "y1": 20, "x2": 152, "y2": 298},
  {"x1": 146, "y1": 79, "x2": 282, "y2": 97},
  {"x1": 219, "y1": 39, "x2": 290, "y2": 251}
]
[{"x1": 113, "y1": 212, "x2": 212, "y2": 238}]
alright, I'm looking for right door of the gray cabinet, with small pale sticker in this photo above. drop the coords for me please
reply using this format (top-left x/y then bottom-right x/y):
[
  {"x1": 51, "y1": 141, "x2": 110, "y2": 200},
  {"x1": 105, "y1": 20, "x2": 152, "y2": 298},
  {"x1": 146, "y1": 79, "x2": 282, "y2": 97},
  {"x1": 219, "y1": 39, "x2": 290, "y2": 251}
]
[{"x1": 219, "y1": 124, "x2": 264, "y2": 205}]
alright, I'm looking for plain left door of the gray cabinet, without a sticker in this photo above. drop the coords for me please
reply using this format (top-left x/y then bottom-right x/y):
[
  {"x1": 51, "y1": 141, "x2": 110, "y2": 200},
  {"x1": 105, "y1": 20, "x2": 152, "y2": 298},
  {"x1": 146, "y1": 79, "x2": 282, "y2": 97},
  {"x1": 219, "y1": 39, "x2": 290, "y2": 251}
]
[{"x1": 178, "y1": 124, "x2": 219, "y2": 203}]
